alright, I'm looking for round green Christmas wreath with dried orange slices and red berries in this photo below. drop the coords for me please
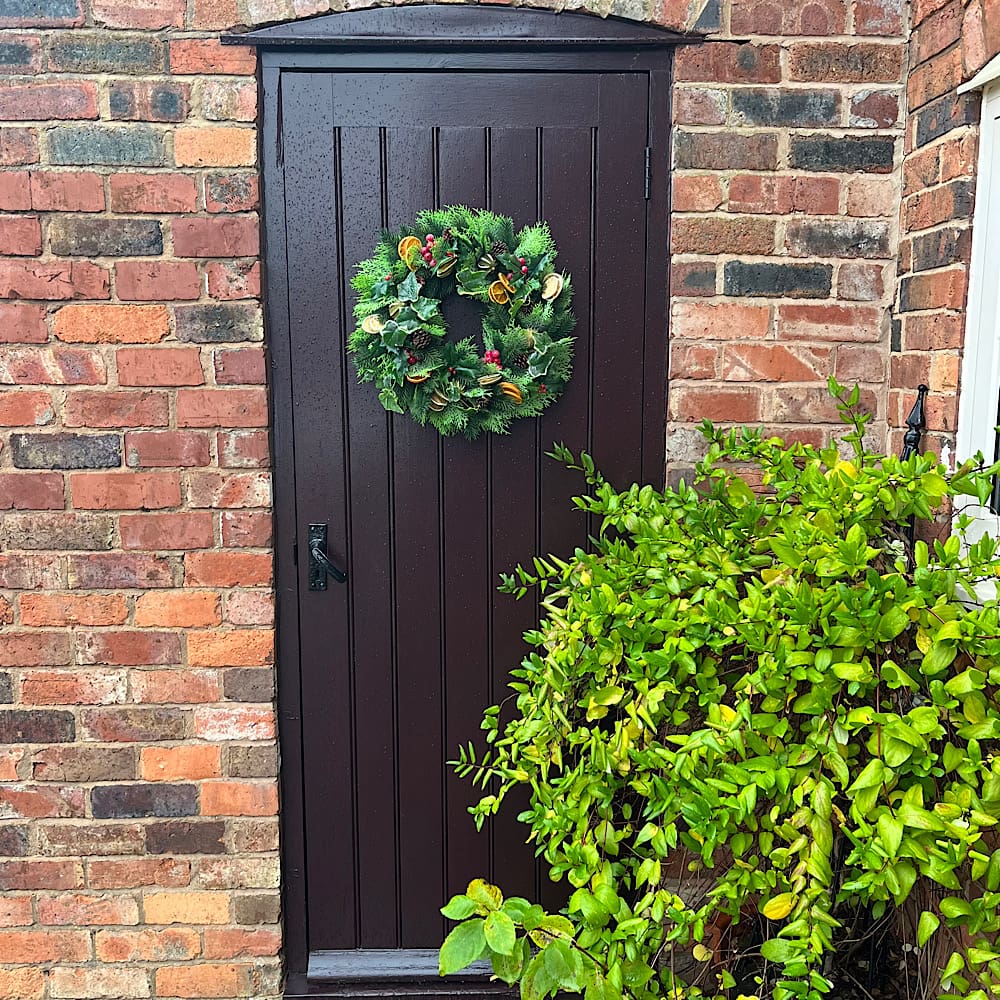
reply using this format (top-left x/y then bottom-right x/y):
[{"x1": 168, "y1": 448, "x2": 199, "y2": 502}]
[{"x1": 349, "y1": 206, "x2": 576, "y2": 438}]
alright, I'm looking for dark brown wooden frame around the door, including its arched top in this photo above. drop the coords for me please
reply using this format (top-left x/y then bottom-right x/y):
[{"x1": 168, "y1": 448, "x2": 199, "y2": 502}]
[{"x1": 231, "y1": 4, "x2": 688, "y2": 997}]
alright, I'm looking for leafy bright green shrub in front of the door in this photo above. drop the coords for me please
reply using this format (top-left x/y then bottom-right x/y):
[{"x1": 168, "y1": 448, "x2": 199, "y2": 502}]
[{"x1": 440, "y1": 380, "x2": 1000, "y2": 1000}]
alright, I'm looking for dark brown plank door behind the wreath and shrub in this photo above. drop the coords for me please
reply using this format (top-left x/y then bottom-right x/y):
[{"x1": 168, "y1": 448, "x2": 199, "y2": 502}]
[{"x1": 265, "y1": 35, "x2": 667, "y2": 995}]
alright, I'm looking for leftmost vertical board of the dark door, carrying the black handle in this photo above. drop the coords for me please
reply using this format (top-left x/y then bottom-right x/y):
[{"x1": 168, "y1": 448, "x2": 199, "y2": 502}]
[{"x1": 282, "y1": 74, "x2": 357, "y2": 948}]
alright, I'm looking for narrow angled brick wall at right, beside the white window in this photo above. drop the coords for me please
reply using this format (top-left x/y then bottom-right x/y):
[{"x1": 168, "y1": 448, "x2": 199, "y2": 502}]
[{"x1": 889, "y1": 0, "x2": 1000, "y2": 458}]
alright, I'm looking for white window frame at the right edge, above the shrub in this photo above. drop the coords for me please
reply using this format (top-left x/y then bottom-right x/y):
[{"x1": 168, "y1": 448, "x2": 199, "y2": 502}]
[{"x1": 955, "y1": 76, "x2": 1000, "y2": 541}]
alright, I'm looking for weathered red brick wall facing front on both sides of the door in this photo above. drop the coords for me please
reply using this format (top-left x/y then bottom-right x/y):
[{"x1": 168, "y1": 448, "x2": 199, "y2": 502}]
[{"x1": 0, "y1": 0, "x2": 915, "y2": 1000}]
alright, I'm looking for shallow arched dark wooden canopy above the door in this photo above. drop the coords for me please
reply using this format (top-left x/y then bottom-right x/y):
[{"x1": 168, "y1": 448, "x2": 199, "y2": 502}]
[{"x1": 222, "y1": 4, "x2": 701, "y2": 51}]
